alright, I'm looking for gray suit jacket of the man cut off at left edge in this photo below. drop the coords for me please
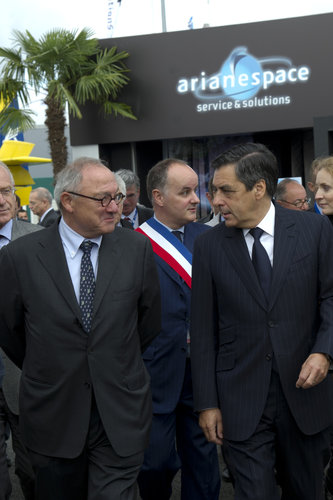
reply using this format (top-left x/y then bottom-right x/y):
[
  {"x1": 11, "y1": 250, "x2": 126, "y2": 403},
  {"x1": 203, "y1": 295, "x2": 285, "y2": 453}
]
[{"x1": 0, "y1": 219, "x2": 43, "y2": 415}]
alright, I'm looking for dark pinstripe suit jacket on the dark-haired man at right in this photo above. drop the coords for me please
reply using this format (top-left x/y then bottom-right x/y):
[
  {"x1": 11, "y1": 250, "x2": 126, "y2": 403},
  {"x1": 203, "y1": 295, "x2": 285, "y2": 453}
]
[{"x1": 191, "y1": 205, "x2": 333, "y2": 440}]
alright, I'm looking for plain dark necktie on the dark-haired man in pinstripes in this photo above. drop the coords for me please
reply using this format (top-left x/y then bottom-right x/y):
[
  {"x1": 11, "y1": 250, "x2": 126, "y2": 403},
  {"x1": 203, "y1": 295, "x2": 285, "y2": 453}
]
[{"x1": 250, "y1": 227, "x2": 272, "y2": 299}]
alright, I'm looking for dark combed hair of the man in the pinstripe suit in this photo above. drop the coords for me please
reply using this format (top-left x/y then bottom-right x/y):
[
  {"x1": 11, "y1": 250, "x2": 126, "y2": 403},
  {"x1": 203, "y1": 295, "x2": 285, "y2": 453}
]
[{"x1": 211, "y1": 142, "x2": 279, "y2": 198}]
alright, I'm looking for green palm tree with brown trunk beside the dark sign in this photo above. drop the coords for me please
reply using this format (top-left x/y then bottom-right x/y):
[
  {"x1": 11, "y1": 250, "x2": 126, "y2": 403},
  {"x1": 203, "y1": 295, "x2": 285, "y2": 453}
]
[{"x1": 0, "y1": 28, "x2": 135, "y2": 175}]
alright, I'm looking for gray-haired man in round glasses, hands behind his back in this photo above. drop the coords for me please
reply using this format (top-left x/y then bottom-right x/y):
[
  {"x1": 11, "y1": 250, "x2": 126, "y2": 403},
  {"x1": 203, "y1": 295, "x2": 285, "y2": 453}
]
[{"x1": 0, "y1": 158, "x2": 160, "y2": 500}]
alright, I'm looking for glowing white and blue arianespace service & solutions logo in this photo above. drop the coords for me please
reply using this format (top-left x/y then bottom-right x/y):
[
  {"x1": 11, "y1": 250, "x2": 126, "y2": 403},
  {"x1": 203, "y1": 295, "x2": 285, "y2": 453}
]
[{"x1": 177, "y1": 47, "x2": 310, "y2": 112}]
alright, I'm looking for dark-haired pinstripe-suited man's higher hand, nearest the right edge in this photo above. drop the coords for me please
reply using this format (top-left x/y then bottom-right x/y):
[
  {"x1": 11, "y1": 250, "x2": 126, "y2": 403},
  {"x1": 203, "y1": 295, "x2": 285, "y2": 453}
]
[{"x1": 296, "y1": 352, "x2": 330, "y2": 389}]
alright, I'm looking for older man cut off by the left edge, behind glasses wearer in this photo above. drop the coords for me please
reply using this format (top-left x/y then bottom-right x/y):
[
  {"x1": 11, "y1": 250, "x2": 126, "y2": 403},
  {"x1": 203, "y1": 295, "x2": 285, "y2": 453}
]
[{"x1": 0, "y1": 162, "x2": 43, "y2": 500}]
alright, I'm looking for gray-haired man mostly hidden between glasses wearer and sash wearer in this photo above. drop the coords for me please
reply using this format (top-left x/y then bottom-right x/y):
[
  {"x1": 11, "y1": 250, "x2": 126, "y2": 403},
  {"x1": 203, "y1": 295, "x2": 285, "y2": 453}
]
[{"x1": 116, "y1": 169, "x2": 154, "y2": 229}]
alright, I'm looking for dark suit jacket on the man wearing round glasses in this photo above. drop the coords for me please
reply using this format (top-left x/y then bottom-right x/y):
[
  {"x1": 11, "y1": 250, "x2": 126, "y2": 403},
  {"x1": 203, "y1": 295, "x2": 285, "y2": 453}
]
[{"x1": 0, "y1": 224, "x2": 160, "y2": 458}]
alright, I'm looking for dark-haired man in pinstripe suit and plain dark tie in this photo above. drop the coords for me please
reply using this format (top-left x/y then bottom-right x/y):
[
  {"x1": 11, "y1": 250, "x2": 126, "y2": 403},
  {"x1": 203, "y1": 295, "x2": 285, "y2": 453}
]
[{"x1": 191, "y1": 144, "x2": 333, "y2": 500}]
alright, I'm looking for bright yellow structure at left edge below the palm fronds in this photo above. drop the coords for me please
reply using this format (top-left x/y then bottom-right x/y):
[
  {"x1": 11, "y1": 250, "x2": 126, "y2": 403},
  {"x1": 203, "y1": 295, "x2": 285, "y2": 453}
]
[{"x1": 0, "y1": 140, "x2": 51, "y2": 205}]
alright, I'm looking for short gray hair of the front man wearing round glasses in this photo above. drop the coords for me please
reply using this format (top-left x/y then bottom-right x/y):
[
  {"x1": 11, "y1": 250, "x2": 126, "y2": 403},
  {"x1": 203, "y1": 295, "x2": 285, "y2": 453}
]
[{"x1": 54, "y1": 156, "x2": 107, "y2": 211}]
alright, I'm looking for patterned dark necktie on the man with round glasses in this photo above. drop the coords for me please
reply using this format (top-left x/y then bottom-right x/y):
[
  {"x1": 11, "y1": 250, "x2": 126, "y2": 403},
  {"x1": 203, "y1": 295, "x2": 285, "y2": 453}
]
[{"x1": 80, "y1": 240, "x2": 95, "y2": 333}]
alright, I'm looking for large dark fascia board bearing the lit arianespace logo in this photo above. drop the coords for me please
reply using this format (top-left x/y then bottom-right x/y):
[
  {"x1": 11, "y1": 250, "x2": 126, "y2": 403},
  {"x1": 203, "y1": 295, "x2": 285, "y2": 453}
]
[{"x1": 70, "y1": 14, "x2": 333, "y2": 145}]
